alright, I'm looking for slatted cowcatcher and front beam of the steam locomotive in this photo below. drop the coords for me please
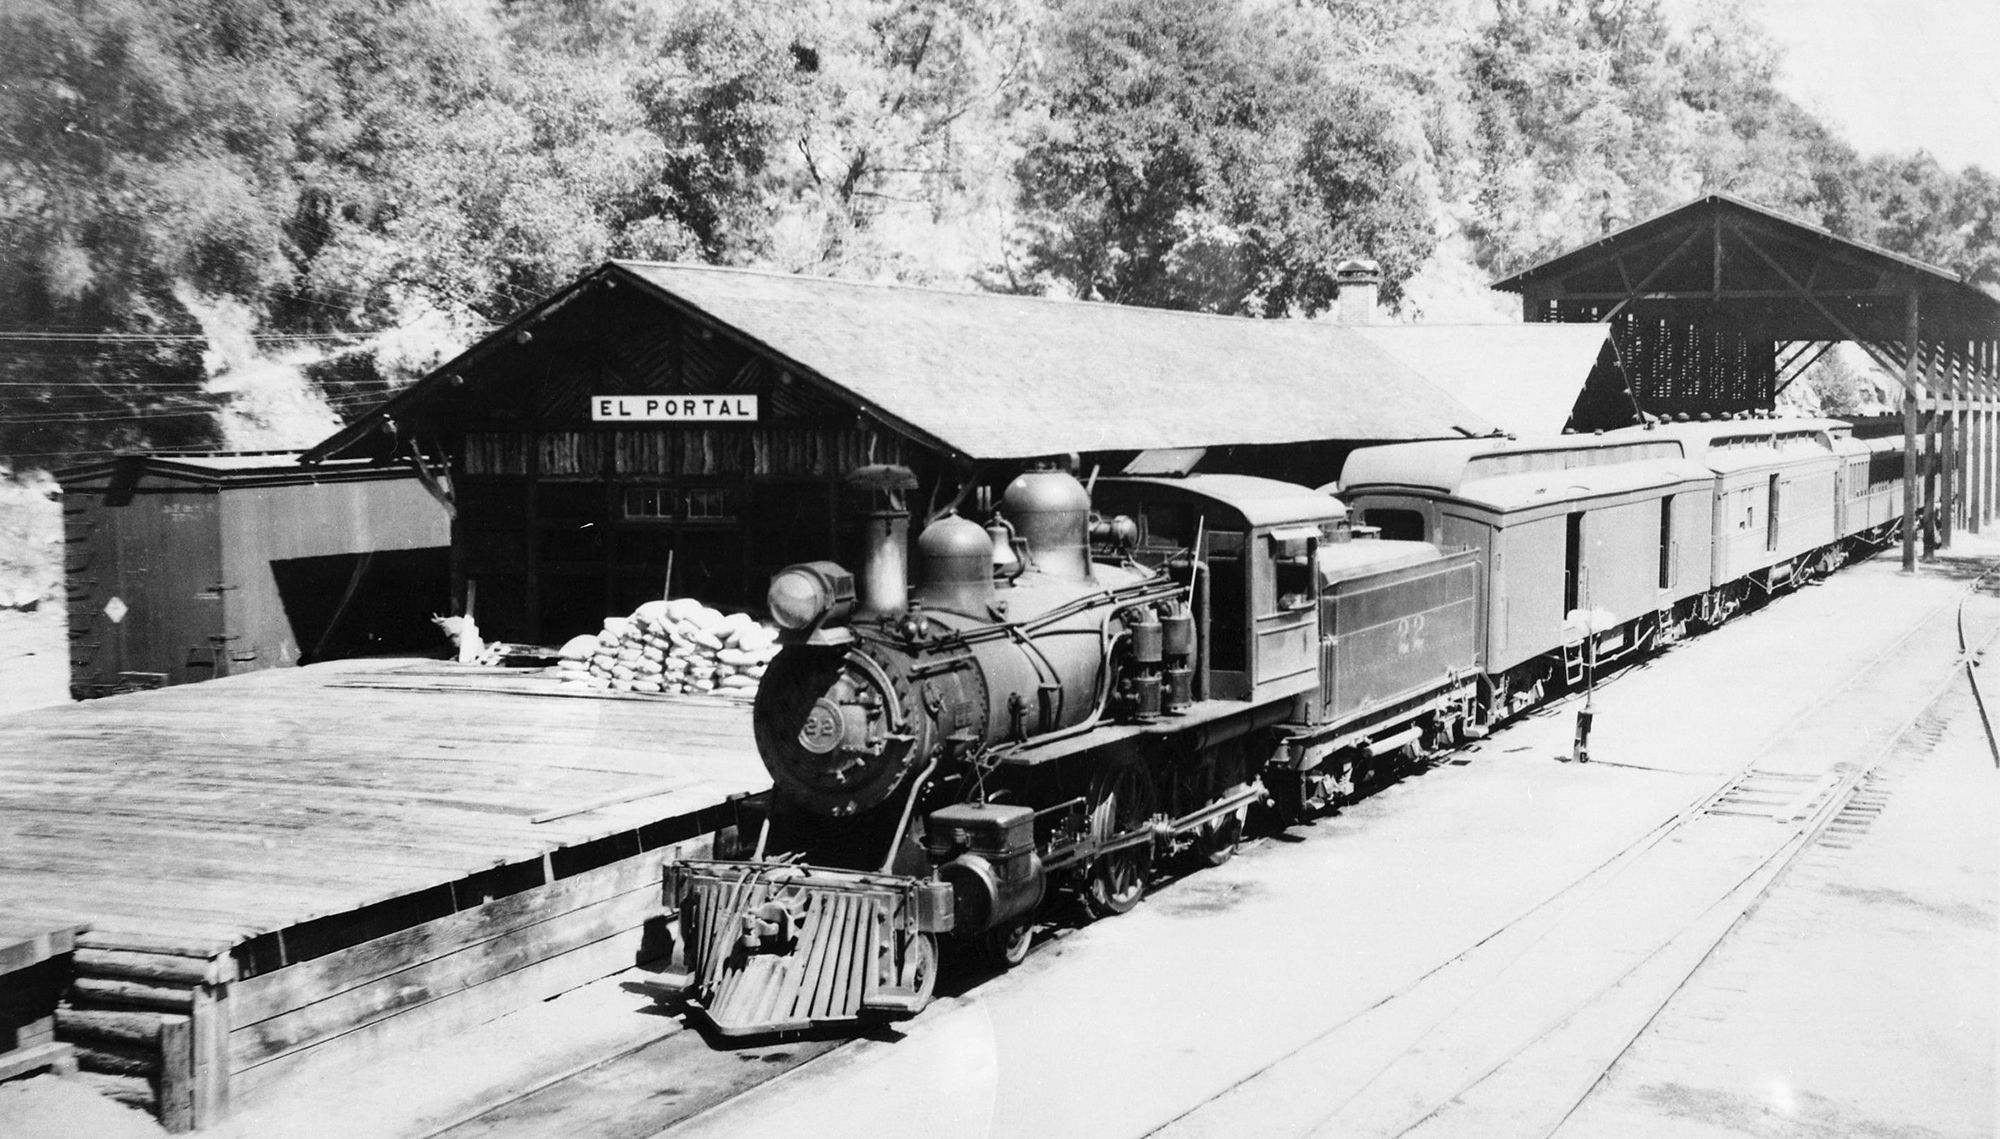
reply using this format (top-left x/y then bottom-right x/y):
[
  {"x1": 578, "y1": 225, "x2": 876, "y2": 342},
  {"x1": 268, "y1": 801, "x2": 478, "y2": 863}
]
[{"x1": 648, "y1": 861, "x2": 952, "y2": 1037}]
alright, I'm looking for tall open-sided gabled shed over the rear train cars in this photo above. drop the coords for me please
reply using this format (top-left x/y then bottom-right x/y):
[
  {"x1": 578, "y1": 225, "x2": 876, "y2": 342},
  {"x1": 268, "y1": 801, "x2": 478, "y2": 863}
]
[{"x1": 1494, "y1": 194, "x2": 2000, "y2": 568}]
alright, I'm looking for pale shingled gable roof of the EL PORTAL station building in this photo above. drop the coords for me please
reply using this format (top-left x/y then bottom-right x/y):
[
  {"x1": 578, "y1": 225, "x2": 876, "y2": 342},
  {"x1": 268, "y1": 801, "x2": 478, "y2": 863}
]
[{"x1": 306, "y1": 262, "x2": 1504, "y2": 462}]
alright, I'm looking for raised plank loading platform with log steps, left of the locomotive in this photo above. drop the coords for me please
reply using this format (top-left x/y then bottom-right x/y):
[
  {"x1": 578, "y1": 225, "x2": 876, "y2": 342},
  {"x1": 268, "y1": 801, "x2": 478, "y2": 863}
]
[{"x1": 0, "y1": 661, "x2": 768, "y2": 1129}]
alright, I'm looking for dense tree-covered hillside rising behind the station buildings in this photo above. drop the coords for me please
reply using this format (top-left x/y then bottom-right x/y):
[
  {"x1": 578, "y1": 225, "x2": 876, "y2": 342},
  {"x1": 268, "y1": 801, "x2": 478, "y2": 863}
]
[{"x1": 0, "y1": 0, "x2": 2000, "y2": 466}]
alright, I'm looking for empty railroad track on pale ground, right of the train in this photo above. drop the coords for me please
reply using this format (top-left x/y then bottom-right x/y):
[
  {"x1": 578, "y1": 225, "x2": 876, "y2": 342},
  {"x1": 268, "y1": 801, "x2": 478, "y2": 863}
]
[{"x1": 1146, "y1": 573, "x2": 2000, "y2": 1139}]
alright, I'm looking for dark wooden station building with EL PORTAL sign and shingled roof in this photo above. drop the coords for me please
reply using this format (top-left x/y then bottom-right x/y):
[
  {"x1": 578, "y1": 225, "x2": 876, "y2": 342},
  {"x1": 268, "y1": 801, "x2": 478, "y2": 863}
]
[{"x1": 304, "y1": 262, "x2": 1602, "y2": 643}]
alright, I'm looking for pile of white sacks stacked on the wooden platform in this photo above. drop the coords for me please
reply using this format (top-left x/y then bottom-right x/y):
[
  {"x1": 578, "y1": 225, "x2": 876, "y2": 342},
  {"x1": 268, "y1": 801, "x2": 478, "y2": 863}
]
[{"x1": 556, "y1": 597, "x2": 778, "y2": 697}]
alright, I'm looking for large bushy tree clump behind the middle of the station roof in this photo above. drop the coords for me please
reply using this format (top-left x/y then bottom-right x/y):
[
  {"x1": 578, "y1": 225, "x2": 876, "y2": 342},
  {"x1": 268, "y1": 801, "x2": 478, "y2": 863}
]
[{"x1": 1014, "y1": 0, "x2": 1430, "y2": 316}]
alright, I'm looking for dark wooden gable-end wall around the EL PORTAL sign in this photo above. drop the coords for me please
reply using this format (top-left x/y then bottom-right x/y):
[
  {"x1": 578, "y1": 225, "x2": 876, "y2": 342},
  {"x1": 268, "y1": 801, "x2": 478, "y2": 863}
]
[{"x1": 444, "y1": 286, "x2": 936, "y2": 643}]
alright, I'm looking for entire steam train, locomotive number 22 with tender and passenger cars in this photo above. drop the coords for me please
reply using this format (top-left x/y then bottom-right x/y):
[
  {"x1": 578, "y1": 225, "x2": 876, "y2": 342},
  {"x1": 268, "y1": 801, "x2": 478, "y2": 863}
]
[{"x1": 662, "y1": 422, "x2": 1902, "y2": 1035}]
